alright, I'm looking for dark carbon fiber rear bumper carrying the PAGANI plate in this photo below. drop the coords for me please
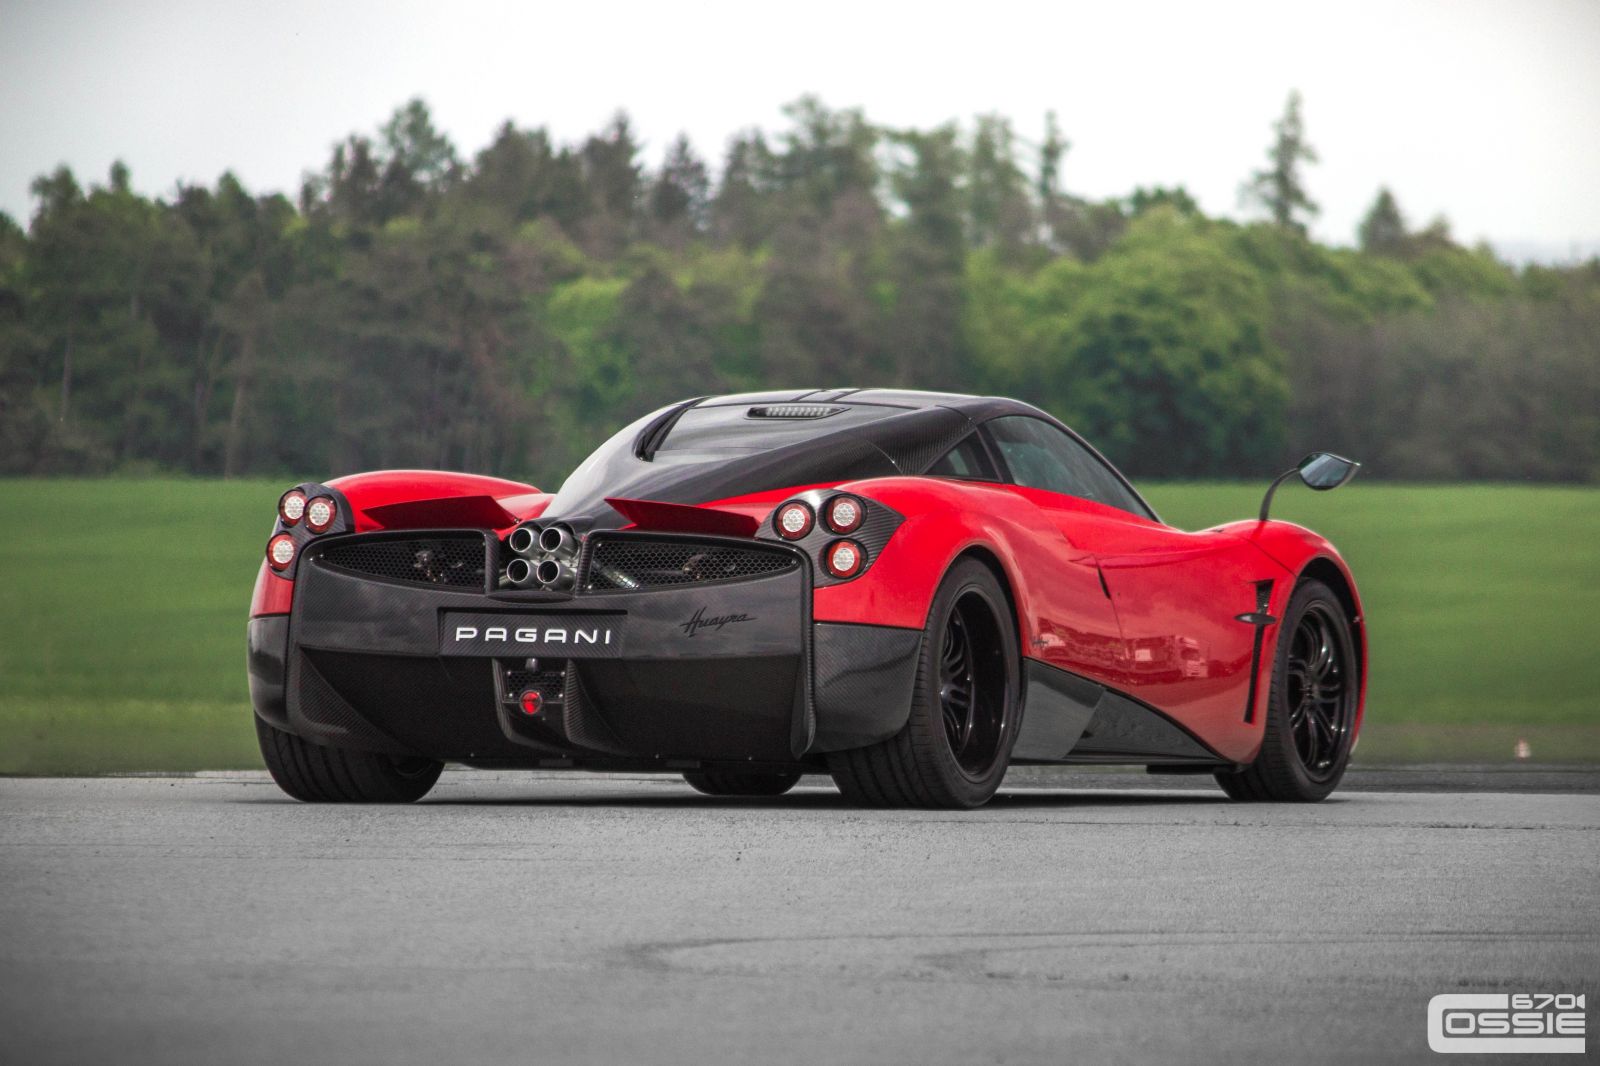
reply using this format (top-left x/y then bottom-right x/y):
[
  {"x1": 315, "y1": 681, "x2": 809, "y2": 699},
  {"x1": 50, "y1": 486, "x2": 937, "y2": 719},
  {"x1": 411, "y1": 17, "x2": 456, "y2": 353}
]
[{"x1": 250, "y1": 538, "x2": 920, "y2": 767}]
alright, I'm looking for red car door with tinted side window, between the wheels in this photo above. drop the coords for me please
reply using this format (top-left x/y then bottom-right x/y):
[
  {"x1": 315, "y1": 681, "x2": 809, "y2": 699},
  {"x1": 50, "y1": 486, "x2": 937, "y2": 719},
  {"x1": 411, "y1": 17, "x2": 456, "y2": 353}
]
[{"x1": 986, "y1": 416, "x2": 1282, "y2": 754}]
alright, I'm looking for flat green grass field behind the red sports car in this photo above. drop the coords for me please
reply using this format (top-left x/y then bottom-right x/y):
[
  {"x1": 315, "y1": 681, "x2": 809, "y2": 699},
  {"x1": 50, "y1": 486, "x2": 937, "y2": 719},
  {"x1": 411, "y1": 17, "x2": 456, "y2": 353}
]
[{"x1": 0, "y1": 480, "x2": 1600, "y2": 773}]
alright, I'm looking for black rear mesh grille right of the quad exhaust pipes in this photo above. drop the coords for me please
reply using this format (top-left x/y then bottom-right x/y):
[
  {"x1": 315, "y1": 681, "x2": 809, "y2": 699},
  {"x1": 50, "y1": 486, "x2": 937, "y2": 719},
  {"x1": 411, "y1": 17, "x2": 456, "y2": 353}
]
[{"x1": 582, "y1": 536, "x2": 800, "y2": 592}]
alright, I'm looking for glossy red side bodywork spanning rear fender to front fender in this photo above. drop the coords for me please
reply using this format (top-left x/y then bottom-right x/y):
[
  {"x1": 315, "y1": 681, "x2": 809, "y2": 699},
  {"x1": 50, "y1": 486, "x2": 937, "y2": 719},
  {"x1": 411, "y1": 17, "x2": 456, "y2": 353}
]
[{"x1": 718, "y1": 477, "x2": 1366, "y2": 762}]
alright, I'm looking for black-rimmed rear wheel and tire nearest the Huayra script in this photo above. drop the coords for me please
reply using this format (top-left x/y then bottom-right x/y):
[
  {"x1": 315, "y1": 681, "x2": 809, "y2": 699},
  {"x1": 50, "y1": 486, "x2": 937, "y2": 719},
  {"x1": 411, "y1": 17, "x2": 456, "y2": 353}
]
[{"x1": 827, "y1": 559, "x2": 1021, "y2": 810}]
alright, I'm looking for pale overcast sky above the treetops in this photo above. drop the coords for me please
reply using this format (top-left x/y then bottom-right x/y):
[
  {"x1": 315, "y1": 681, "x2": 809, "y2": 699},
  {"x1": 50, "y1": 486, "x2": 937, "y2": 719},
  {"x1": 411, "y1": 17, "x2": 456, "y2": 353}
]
[{"x1": 9, "y1": 0, "x2": 1600, "y2": 259}]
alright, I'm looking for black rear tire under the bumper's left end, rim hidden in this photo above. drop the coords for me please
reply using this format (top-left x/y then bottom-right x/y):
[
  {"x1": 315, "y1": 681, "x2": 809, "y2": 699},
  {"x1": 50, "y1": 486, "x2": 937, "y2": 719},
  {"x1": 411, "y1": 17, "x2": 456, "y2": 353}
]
[{"x1": 256, "y1": 717, "x2": 445, "y2": 804}]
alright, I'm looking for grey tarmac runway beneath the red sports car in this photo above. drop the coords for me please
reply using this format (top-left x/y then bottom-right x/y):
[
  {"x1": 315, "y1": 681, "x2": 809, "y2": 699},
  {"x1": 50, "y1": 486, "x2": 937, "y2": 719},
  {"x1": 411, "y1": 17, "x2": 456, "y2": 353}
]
[{"x1": 0, "y1": 771, "x2": 1600, "y2": 1066}]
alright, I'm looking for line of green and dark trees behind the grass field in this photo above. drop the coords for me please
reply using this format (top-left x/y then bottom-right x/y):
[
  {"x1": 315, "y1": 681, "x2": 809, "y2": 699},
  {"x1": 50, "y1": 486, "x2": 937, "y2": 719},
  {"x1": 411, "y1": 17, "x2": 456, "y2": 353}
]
[{"x1": 0, "y1": 96, "x2": 1600, "y2": 487}]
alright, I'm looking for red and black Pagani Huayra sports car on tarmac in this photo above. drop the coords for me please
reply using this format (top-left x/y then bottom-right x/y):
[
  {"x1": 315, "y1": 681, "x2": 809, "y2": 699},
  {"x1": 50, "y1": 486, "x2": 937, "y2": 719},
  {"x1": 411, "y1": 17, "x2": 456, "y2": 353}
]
[{"x1": 250, "y1": 389, "x2": 1366, "y2": 807}]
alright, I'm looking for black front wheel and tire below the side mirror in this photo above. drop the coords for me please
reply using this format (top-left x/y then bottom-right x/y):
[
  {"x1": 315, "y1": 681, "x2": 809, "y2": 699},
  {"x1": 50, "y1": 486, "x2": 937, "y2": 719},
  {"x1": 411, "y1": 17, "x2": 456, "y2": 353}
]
[{"x1": 1216, "y1": 581, "x2": 1362, "y2": 804}]
